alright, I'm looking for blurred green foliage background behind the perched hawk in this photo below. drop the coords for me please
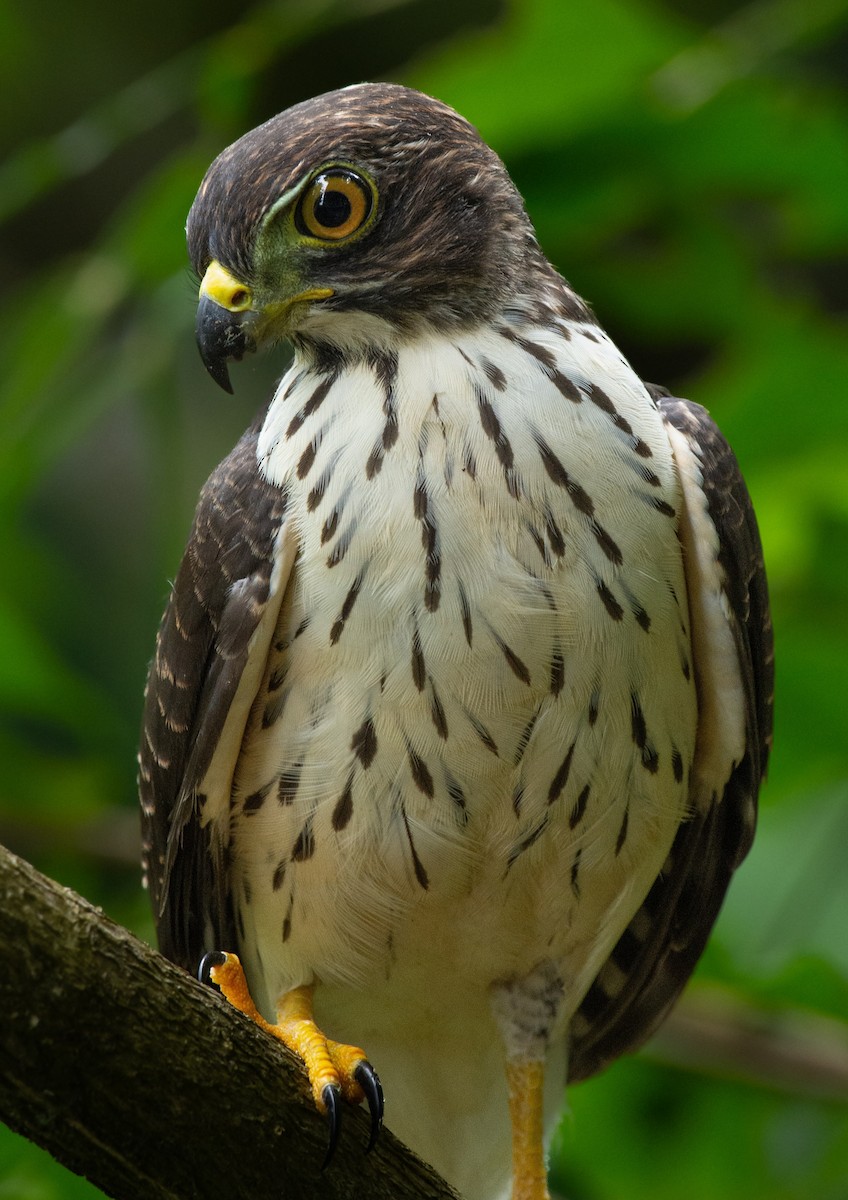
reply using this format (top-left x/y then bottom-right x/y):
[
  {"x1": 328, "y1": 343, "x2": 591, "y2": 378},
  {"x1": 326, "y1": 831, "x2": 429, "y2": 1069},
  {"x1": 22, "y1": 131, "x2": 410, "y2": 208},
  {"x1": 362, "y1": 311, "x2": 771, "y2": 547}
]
[{"x1": 0, "y1": 0, "x2": 848, "y2": 1200}]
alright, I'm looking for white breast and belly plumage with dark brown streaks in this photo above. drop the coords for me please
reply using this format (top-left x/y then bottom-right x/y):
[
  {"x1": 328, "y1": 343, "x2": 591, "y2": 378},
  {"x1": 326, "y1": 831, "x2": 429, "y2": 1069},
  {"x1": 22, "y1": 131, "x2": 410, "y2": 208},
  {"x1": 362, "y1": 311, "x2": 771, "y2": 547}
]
[{"x1": 224, "y1": 326, "x2": 697, "y2": 1190}]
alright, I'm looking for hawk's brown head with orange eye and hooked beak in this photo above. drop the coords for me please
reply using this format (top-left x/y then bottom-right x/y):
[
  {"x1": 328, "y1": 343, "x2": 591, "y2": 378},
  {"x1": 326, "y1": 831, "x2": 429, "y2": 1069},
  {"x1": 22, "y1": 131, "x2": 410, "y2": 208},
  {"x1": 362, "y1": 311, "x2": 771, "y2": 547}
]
[{"x1": 187, "y1": 84, "x2": 535, "y2": 391}]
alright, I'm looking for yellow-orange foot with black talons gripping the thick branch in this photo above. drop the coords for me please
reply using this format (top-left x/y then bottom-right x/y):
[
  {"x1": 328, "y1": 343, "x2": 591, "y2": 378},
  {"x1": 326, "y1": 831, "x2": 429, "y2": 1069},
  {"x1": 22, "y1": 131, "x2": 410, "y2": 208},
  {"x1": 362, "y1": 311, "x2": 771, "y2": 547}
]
[{"x1": 198, "y1": 950, "x2": 383, "y2": 1166}]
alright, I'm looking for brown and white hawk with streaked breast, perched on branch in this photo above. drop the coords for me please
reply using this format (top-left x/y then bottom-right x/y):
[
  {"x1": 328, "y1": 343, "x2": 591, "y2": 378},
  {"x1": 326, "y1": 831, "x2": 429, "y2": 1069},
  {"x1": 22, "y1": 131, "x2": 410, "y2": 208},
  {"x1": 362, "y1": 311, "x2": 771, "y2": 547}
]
[{"x1": 140, "y1": 84, "x2": 772, "y2": 1200}]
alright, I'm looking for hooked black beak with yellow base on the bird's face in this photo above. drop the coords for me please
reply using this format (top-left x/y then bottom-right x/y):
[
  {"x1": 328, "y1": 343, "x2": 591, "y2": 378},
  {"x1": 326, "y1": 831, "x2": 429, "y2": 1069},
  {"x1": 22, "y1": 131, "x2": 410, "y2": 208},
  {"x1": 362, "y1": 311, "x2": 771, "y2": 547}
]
[{"x1": 194, "y1": 259, "x2": 257, "y2": 395}]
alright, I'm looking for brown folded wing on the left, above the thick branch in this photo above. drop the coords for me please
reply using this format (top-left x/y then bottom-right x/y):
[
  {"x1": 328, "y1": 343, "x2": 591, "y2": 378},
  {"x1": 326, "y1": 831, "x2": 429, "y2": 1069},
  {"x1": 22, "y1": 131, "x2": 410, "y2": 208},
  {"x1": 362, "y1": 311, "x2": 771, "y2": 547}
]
[{"x1": 139, "y1": 424, "x2": 285, "y2": 971}]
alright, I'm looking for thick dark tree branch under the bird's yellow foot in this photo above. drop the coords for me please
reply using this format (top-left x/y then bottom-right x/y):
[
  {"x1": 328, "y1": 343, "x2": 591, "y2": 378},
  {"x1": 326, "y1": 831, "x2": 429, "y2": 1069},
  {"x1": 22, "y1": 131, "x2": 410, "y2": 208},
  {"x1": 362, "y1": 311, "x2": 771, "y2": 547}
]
[{"x1": 0, "y1": 847, "x2": 456, "y2": 1200}]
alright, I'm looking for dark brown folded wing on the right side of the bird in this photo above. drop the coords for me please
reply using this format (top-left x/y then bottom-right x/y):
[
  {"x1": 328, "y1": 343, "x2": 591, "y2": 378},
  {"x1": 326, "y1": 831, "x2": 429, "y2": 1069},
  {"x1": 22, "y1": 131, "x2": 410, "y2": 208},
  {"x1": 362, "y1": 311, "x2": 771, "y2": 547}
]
[{"x1": 569, "y1": 389, "x2": 774, "y2": 1081}]
